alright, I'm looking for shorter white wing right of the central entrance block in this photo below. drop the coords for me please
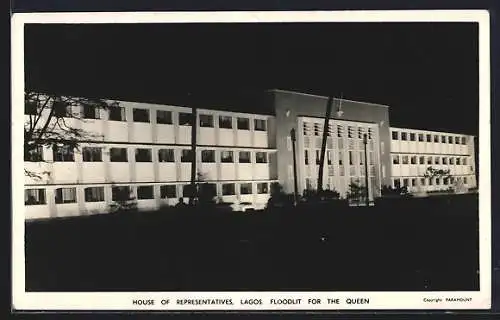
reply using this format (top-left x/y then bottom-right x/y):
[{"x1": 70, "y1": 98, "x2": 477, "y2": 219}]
[{"x1": 391, "y1": 128, "x2": 477, "y2": 193}]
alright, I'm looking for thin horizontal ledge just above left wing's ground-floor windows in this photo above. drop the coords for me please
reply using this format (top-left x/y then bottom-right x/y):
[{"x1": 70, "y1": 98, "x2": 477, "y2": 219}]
[{"x1": 24, "y1": 179, "x2": 278, "y2": 187}]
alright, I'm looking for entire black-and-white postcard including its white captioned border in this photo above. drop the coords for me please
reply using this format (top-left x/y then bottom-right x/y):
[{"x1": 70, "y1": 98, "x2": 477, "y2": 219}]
[{"x1": 12, "y1": 11, "x2": 491, "y2": 310}]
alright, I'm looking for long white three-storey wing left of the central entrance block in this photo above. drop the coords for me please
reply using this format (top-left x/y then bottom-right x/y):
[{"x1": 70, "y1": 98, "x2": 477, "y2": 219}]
[{"x1": 24, "y1": 102, "x2": 276, "y2": 220}]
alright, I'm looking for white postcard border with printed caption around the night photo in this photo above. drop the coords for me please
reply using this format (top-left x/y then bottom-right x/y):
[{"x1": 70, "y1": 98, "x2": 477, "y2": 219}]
[{"x1": 11, "y1": 10, "x2": 491, "y2": 310}]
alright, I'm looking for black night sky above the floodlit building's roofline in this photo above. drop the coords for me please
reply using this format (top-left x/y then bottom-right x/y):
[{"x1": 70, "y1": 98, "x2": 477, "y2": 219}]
[{"x1": 25, "y1": 23, "x2": 479, "y2": 135}]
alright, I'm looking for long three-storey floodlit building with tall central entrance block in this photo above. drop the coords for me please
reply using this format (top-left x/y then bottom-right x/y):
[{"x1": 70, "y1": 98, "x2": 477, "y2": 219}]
[{"x1": 25, "y1": 90, "x2": 476, "y2": 219}]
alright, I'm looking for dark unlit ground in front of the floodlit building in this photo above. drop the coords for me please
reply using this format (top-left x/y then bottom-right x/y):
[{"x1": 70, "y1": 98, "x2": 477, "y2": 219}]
[{"x1": 26, "y1": 195, "x2": 479, "y2": 291}]
